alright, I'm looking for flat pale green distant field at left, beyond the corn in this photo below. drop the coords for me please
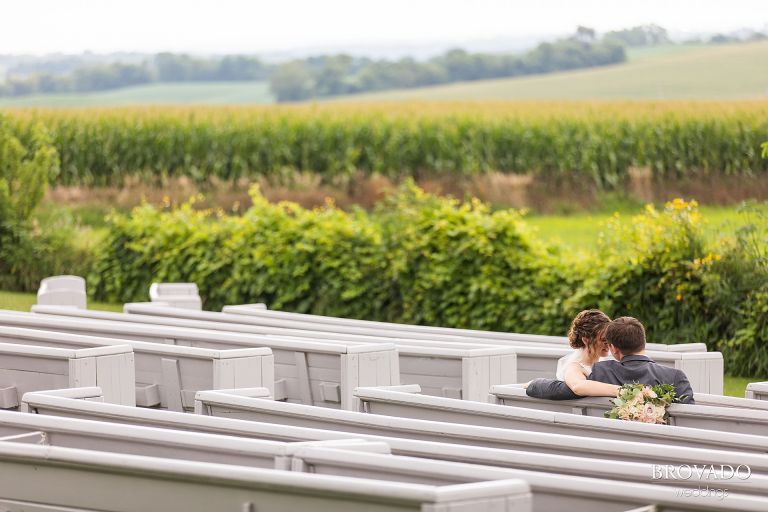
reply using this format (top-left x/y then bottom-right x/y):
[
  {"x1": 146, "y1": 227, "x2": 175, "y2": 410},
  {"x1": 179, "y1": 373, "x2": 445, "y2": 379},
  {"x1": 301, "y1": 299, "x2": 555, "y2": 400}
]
[{"x1": 0, "y1": 82, "x2": 274, "y2": 107}]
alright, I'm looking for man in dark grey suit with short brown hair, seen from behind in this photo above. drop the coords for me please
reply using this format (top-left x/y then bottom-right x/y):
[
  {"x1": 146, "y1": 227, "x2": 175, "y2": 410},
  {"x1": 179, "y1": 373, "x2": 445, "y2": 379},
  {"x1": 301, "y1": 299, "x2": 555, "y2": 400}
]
[{"x1": 526, "y1": 316, "x2": 694, "y2": 404}]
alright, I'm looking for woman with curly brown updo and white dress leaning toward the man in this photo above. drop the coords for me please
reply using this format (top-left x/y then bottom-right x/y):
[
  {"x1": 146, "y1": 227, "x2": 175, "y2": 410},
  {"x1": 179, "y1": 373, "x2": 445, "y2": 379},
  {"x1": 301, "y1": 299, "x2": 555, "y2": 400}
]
[{"x1": 556, "y1": 309, "x2": 619, "y2": 396}]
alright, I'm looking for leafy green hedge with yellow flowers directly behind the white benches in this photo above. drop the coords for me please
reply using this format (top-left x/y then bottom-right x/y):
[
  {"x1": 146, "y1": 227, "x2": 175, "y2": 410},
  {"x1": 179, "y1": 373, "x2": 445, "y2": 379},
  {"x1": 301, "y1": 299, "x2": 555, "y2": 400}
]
[{"x1": 89, "y1": 185, "x2": 768, "y2": 377}]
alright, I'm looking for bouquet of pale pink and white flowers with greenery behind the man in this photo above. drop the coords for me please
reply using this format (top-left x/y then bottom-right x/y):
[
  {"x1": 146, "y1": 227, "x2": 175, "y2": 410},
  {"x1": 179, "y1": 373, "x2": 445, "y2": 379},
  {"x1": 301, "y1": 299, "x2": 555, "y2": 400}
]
[{"x1": 605, "y1": 384, "x2": 680, "y2": 425}]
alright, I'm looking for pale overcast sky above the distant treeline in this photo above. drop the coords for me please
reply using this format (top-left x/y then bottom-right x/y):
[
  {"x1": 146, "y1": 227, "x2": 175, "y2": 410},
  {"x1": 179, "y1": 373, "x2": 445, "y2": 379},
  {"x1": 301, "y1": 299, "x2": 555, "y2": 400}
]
[{"x1": 0, "y1": 0, "x2": 768, "y2": 54}]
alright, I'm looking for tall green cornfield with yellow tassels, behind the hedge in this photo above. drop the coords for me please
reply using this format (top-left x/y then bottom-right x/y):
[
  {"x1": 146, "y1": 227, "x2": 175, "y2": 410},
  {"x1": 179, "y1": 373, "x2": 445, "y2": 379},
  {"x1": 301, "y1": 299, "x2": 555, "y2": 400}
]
[{"x1": 12, "y1": 102, "x2": 768, "y2": 188}]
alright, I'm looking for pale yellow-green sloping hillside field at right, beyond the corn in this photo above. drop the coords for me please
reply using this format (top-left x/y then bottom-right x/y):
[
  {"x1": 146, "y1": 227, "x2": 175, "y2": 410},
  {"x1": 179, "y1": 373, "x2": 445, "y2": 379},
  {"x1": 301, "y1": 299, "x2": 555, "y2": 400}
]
[{"x1": 335, "y1": 42, "x2": 768, "y2": 102}]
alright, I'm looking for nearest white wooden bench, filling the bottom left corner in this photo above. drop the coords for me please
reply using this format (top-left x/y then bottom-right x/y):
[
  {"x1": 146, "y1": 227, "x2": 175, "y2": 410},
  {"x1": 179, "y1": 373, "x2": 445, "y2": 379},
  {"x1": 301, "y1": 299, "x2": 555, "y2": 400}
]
[{"x1": 0, "y1": 441, "x2": 531, "y2": 512}]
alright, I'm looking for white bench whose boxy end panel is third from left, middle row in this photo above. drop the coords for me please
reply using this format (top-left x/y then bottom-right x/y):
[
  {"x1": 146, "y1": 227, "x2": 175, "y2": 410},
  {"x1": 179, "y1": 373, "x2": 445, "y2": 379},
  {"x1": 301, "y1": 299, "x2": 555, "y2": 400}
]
[{"x1": 0, "y1": 310, "x2": 400, "y2": 410}]
